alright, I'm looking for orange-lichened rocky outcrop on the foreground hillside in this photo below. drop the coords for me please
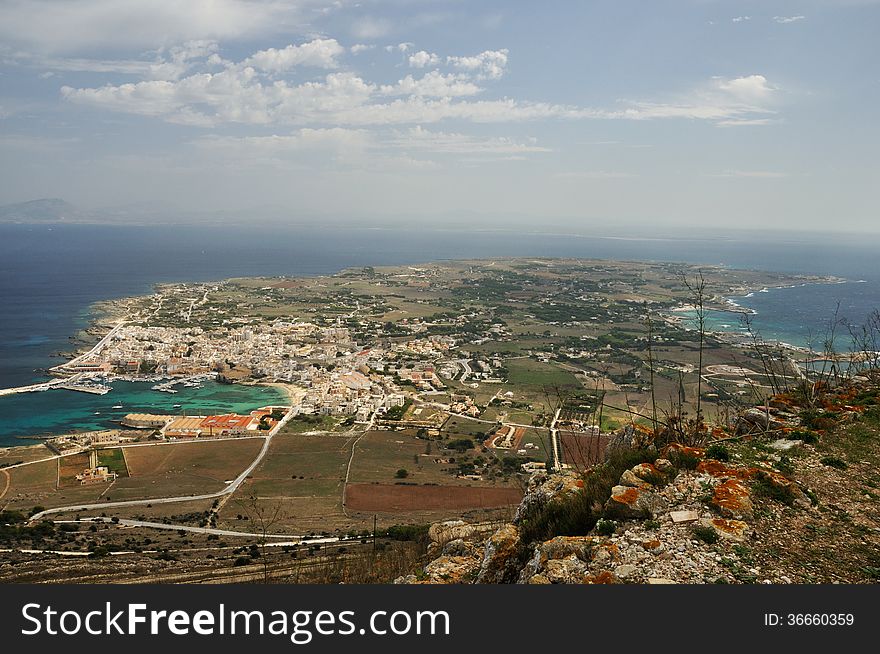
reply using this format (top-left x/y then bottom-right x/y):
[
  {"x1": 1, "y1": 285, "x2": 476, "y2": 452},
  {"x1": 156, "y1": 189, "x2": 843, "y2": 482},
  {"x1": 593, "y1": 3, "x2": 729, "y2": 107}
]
[{"x1": 402, "y1": 398, "x2": 828, "y2": 584}]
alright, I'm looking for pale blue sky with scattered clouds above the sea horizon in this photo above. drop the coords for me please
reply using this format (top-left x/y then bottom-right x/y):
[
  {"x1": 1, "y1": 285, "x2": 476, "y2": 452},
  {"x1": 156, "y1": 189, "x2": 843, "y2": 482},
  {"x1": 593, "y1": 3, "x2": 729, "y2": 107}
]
[{"x1": 0, "y1": 0, "x2": 880, "y2": 232}]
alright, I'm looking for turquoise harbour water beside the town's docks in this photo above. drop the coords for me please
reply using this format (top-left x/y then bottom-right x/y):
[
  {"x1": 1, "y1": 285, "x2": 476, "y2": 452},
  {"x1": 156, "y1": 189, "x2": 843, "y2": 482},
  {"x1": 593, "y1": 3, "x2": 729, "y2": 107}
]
[{"x1": 0, "y1": 382, "x2": 288, "y2": 445}]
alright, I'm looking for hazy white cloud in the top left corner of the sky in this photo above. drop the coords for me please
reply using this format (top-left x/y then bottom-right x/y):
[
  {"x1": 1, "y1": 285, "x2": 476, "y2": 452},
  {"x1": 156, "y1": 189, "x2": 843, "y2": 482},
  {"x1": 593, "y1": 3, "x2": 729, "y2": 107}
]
[{"x1": 0, "y1": 0, "x2": 317, "y2": 54}]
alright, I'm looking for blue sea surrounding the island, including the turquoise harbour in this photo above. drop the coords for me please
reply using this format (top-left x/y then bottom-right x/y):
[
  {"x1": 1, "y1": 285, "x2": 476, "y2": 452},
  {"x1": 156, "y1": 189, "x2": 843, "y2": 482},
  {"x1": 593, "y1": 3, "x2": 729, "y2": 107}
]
[{"x1": 0, "y1": 225, "x2": 880, "y2": 445}]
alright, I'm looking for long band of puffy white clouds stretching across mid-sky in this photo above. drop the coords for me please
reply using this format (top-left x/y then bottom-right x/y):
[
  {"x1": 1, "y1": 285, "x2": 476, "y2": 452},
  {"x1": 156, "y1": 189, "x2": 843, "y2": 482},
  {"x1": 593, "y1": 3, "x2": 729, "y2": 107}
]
[{"x1": 61, "y1": 39, "x2": 775, "y2": 127}]
